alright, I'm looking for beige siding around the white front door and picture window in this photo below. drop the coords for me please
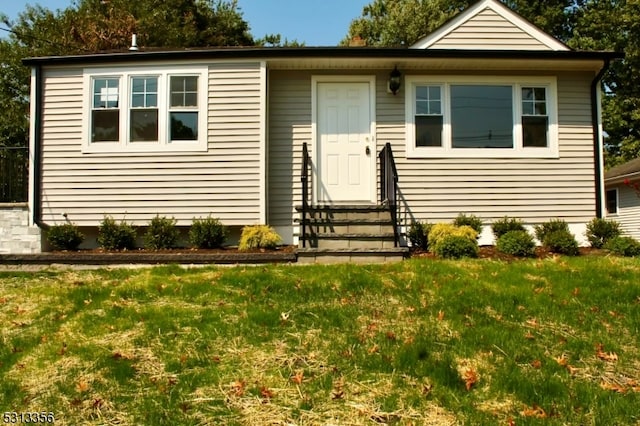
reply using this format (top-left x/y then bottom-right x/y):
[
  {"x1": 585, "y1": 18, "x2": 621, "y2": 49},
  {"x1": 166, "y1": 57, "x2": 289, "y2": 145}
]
[{"x1": 269, "y1": 70, "x2": 595, "y2": 238}]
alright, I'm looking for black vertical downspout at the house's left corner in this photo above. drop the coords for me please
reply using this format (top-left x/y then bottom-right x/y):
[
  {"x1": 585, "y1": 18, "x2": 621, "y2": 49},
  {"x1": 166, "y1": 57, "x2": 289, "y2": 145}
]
[{"x1": 31, "y1": 64, "x2": 45, "y2": 228}]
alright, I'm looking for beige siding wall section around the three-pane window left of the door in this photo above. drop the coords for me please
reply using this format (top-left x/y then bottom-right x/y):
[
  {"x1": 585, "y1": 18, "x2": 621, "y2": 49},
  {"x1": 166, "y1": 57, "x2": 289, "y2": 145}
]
[{"x1": 42, "y1": 64, "x2": 264, "y2": 226}]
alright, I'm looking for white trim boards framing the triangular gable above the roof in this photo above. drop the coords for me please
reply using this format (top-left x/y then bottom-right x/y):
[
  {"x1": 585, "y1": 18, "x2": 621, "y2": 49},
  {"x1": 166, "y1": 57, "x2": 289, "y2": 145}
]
[{"x1": 411, "y1": 0, "x2": 571, "y2": 51}]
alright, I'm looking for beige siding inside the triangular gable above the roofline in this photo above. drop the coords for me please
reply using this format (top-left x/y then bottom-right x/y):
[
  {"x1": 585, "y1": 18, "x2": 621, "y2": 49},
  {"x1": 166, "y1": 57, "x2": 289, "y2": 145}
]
[{"x1": 429, "y1": 8, "x2": 550, "y2": 50}]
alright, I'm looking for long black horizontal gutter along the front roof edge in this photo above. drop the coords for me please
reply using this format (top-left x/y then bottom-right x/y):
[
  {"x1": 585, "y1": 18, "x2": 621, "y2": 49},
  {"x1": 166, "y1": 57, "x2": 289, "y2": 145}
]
[{"x1": 22, "y1": 47, "x2": 623, "y2": 66}]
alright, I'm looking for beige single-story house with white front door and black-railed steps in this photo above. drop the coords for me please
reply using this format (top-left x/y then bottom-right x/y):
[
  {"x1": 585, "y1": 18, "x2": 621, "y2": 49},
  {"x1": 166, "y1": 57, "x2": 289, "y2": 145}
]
[{"x1": 16, "y1": 0, "x2": 620, "y2": 260}]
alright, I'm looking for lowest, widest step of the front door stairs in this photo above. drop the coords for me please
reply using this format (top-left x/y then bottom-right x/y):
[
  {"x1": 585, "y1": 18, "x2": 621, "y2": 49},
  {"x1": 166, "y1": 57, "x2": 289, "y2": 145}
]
[{"x1": 296, "y1": 247, "x2": 409, "y2": 264}]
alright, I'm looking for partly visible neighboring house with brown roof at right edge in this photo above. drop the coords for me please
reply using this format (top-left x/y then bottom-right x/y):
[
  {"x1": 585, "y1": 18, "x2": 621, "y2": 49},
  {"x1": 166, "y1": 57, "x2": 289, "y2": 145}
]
[{"x1": 604, "y1": 158, "x2": 640, "y2": 240}]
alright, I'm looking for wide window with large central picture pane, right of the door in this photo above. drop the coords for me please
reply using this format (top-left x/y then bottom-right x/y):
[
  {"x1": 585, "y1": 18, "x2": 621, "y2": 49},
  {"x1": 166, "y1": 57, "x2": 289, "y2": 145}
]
[{"x1": 406, "y1": 76, "x2": 558, "y2": 158}]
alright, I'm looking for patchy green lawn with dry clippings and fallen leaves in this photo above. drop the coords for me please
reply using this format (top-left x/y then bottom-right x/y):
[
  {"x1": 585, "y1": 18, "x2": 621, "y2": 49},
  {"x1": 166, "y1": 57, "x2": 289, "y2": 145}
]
[{"x1": 0, "y1": 257, "x2": 640, "y2": 425}]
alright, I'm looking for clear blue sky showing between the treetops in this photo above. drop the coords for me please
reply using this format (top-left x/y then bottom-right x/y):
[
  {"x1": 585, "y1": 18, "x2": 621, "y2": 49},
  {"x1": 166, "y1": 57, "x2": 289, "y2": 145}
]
[{"x1": 0, "y1": 0, "x2": 373, "y2": 46}]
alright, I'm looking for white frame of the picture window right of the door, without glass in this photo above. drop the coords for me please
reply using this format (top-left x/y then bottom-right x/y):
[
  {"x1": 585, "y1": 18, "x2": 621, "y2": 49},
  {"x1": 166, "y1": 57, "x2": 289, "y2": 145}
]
[{"x1": 405, "y1": 76, "x2": 559, "y2": 158}]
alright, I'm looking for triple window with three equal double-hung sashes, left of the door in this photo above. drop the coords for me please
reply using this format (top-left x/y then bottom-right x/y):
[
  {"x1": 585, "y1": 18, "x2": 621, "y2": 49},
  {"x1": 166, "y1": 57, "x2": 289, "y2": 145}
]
[{"x1": 84, "y1": 67, "x2": 207, "y2": 153}]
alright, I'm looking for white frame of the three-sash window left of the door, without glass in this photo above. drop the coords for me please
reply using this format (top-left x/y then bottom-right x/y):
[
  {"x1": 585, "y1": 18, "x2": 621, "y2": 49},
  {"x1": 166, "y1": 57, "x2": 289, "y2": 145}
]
[{"x1": 82, "y1": 65, "x2": 208, "y2": 154}]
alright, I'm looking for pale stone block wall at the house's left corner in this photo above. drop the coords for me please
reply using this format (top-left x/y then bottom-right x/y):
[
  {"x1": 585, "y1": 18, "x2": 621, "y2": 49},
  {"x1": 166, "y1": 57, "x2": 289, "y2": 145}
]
[{"x1": 0, "y1": 203, "x2": 42, "y2": 254}]
